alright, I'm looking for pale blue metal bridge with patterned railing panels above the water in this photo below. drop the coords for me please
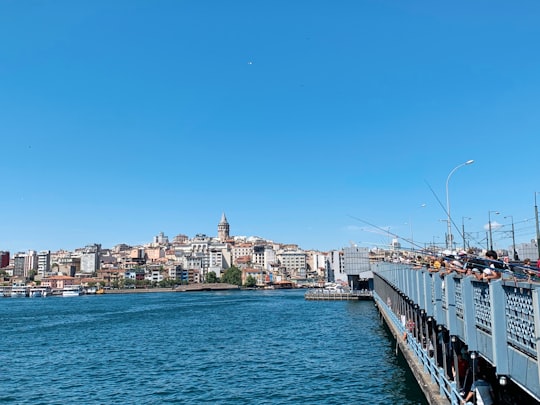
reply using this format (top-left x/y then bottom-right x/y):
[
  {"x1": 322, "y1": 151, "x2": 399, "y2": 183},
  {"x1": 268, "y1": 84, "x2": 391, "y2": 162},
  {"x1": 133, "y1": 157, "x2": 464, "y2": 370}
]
[{"x1": 370, "y1": 261, "x2": 540, "y2": 404}]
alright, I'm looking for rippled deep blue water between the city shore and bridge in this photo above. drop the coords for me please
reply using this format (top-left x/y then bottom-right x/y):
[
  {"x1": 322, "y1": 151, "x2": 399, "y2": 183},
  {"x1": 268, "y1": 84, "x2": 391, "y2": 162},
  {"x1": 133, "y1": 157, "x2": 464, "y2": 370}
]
[{"x1": 0, "y1": 290, "x2": 427, "y2": 404}]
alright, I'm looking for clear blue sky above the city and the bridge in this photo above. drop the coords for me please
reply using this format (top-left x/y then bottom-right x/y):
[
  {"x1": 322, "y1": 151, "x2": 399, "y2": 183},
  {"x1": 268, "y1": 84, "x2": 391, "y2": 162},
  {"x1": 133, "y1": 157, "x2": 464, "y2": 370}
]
[{"x1": 0, "y1": 0, "x2": 540, "y2": 252}]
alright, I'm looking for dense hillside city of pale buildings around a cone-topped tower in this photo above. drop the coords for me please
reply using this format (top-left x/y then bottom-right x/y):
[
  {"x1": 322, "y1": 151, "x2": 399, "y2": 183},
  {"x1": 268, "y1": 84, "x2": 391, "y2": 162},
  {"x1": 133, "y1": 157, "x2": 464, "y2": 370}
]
[{"x1": 0, "y1": 213, "x2": 346, "y2": 289}]
